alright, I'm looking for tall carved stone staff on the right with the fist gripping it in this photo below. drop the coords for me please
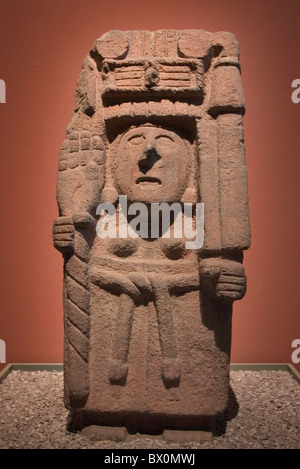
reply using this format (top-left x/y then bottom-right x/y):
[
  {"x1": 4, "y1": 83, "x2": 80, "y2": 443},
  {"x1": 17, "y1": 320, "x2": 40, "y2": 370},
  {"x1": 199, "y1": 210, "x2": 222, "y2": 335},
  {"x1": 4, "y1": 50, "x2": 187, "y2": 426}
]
[{"x1": 200, "y1": 32, "x2": 250, "y2": 302}]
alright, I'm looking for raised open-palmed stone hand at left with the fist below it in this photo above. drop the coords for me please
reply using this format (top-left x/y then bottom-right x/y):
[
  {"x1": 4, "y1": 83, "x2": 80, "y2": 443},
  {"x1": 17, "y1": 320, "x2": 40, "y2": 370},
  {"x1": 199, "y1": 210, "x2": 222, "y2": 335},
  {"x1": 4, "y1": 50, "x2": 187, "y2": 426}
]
[{"x1": 53, "y1": 131, "x2": 103, "y2": 254}]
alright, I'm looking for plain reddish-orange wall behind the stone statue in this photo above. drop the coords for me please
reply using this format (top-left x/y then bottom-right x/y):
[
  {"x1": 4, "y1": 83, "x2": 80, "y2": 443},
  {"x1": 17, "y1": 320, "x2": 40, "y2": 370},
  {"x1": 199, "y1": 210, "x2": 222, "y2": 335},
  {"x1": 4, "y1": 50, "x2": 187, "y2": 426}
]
[{"x1": 0, "y1": 0, "x2": 300, "y2": 369}]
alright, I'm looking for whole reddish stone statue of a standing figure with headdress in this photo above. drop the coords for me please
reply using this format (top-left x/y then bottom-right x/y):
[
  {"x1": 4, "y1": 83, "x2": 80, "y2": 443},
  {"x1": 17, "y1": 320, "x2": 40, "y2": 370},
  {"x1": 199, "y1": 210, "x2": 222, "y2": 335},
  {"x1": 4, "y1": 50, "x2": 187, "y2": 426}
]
[{"x1": 53, "y1": 30, "x2": 250, "y2": 440}]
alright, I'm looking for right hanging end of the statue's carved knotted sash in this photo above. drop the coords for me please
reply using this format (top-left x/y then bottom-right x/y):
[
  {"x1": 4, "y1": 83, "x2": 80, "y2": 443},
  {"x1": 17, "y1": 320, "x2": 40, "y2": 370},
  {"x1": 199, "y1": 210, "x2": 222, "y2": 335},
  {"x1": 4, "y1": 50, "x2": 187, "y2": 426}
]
[{"x1": 150, "y1": 277, "x2": 180, "y2": 388}]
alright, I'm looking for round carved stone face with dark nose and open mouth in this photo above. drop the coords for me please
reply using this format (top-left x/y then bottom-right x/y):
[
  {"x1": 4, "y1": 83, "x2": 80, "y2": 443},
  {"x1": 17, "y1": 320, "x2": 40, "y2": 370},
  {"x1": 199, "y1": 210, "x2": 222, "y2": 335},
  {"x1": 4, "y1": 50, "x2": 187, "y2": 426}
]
[{"x1": 115, "y1": 125, "x2": 189, "y2": 203}]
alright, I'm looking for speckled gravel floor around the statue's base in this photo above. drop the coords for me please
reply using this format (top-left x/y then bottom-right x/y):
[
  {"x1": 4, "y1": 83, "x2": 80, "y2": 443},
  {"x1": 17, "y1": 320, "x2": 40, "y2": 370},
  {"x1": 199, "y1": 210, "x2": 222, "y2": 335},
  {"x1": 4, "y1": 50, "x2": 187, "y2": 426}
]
[{"x1": 0, "y1": 371, "x2": 300, "y2": 449}]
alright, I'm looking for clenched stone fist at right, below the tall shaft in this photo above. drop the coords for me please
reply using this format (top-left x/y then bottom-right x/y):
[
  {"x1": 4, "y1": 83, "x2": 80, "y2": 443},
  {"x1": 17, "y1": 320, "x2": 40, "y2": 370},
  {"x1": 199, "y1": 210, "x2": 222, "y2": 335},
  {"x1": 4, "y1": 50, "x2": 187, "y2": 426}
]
[{"x1": 200, "y1": 258, "x2": 246, "y2": 303}]
